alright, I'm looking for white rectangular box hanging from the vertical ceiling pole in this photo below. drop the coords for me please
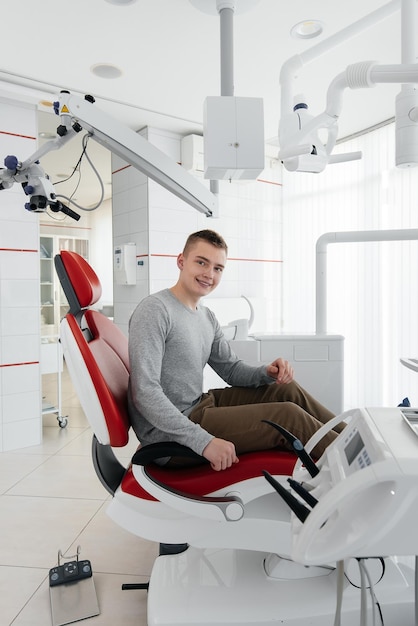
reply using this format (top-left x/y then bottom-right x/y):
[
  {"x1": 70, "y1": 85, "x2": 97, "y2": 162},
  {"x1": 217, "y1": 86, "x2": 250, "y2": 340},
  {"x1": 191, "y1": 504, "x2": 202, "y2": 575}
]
[{"x1": 203, "y1": 96, "x2": 265, "y2": 180}]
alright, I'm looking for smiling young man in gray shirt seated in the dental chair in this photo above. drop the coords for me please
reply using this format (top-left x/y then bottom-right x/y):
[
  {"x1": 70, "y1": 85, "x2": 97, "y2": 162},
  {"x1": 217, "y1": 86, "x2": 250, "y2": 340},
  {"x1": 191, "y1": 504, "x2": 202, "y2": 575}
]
[{"x1": 128, "y1": 230, "x2": 340, "y2": 470}]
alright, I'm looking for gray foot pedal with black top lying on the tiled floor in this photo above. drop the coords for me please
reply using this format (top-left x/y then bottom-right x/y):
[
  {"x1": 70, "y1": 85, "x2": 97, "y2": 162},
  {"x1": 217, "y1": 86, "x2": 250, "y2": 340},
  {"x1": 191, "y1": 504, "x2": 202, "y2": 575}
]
[{"x1": 49, "y1": 546, "x2": 100, "y2": 626}]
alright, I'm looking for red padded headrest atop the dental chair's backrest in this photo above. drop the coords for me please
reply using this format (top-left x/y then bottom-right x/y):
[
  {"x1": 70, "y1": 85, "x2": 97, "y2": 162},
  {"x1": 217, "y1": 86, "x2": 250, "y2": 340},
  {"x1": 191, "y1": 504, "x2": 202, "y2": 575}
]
[{"x1": 55, "y1": 250, "x2": 102, "y2": 314}]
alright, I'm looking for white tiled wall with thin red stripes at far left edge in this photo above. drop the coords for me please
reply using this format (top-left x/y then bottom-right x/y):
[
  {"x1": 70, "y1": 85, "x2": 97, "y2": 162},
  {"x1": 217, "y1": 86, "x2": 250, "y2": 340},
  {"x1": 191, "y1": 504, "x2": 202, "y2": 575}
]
[{"x1": 0, "y1": 99, "x2": 41, "y2": 451}]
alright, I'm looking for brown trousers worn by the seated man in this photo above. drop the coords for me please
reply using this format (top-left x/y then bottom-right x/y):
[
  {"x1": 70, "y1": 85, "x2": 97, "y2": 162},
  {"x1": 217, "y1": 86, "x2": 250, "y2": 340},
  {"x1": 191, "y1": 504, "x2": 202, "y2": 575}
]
[{"x1": 189, "y1": 382, "x2": 343, "y2": 458}]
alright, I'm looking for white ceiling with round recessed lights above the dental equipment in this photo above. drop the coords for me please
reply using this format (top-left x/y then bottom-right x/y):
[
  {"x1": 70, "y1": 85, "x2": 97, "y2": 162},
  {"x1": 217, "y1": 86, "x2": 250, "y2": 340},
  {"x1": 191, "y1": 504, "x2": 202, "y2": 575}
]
[{"x1": 0, "y1": 0, "x2": 401, "y2": 205}]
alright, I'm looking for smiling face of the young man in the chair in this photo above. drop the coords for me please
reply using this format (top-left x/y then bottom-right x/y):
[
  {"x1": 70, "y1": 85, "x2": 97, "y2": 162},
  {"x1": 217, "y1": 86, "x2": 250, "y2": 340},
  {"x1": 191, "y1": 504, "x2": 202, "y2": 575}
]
[{"x1": 177, "y1": 240, "x2": 226, "y2": 298}]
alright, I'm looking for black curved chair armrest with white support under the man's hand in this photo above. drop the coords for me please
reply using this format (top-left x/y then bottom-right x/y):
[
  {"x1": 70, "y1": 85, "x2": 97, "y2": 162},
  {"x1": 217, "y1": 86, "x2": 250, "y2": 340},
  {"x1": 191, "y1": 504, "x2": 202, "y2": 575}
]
[{"x1": 132, "y1": 442, "x2": 244, "y2": 522}]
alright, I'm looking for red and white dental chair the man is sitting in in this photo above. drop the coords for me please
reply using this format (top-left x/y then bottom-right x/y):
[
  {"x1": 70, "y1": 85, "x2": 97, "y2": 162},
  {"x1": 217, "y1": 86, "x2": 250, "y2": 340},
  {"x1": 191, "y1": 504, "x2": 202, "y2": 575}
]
[{"x1": 55, "y1": 251, "x2": 296, "y2": 625}]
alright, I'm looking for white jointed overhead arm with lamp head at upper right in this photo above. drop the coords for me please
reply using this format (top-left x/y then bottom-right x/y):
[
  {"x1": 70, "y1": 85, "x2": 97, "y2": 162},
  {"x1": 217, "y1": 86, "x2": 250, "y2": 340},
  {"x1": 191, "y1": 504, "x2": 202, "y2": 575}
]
[{"x1": 279, "y1": 0, "x2": 418, "y2": 172}]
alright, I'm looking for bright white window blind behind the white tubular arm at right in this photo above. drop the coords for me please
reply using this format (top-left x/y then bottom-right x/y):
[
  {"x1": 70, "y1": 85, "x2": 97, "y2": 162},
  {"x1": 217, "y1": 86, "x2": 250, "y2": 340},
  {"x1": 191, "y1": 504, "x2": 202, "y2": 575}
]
[{"x1": 282, "y1": 124, "x2": 418, "y2": 408}]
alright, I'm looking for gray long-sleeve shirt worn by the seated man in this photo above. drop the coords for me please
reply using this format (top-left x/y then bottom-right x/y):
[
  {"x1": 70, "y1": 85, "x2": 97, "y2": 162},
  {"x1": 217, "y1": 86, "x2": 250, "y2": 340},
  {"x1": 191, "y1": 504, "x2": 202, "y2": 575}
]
[{"x1": 128, "y1": 289, "x2": 272, "y2": 454}]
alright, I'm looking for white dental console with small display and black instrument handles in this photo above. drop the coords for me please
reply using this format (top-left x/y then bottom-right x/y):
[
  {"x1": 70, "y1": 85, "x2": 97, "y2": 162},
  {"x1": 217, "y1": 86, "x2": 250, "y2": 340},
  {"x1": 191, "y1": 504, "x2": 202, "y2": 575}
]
[{"x1": 266, "y1": 408, "x2": 418, "y2": 565}]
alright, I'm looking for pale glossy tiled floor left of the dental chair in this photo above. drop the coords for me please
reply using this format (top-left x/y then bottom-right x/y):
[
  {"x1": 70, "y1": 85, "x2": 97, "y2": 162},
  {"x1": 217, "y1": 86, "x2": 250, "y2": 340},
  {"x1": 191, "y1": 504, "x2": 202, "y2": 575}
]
[{"x1": 0, "y1": 371, "x2": 158, "y2": 626}]
